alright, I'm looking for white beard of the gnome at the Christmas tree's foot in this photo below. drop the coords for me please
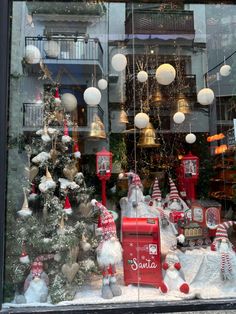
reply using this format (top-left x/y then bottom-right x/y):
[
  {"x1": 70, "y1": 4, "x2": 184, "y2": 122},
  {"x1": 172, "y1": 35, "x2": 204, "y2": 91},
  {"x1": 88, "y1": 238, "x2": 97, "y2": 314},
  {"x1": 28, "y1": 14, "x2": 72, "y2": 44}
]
[{"x1": 25, "y1": 278, "x2": 48, "y2": 303}]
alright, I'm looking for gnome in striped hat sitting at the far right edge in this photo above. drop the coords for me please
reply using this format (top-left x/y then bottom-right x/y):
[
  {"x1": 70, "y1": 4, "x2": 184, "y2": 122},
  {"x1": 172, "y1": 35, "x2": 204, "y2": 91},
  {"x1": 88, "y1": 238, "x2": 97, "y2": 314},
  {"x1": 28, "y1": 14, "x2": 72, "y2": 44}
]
[{"x1": 211, "y1": 221, "x2": 236, "y2": 280}]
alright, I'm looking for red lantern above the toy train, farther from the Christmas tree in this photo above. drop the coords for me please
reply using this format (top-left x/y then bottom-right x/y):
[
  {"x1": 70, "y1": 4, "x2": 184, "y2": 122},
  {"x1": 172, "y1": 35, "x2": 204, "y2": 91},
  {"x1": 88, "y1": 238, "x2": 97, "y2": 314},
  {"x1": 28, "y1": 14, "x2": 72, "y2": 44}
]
[{"x1": 181, "y1": 152, "x2": 199, "y2": 201}]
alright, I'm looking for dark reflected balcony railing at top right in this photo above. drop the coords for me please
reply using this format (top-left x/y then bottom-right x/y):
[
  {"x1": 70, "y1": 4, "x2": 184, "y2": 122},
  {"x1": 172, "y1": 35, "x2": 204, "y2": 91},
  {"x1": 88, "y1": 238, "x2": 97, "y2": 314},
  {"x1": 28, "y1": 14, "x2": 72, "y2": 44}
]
[{"x1": 125, "y1": 11, "x2": 195, "y2": 35}]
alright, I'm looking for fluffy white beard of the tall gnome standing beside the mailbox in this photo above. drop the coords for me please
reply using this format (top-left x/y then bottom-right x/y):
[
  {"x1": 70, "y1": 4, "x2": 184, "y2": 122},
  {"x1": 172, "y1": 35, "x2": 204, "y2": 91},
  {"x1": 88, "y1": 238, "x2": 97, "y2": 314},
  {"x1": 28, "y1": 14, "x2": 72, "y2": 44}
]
[{"x1": 97, "y1": 238, "x2": 122, "y2": 267}]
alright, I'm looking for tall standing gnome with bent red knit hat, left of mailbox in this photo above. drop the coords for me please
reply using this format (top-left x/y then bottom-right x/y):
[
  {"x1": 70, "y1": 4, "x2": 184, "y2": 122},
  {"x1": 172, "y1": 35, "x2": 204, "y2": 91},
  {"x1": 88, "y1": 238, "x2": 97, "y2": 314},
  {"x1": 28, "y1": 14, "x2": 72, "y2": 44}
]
[{"x1": 91, "y1": 200, "x2": 122, "y2": 299}]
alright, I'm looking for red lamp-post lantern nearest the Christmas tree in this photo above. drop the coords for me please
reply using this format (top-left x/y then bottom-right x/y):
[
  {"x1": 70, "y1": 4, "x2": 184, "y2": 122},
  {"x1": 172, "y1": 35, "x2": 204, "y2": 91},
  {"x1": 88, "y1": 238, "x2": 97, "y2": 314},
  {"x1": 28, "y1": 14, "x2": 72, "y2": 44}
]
[{"x1": 96, "y1": 147, "x2": 112, "y2": 206}]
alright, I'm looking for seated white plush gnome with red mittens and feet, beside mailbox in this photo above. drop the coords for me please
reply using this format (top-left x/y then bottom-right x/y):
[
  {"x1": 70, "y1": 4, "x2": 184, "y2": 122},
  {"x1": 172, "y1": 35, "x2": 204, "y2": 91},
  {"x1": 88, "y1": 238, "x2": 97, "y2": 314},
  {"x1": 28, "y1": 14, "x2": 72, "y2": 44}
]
[{"x1": 159, "y1": 249, "x2": 189, "y2": 294}]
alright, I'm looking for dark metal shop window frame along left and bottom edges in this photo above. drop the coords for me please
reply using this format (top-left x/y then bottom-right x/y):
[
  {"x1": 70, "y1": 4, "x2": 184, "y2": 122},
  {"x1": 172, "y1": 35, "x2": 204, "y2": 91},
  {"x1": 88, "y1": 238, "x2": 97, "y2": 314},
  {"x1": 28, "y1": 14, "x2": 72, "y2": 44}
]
[{"x1": 0, "y1": 0, "x2": 236, "y2": 314}]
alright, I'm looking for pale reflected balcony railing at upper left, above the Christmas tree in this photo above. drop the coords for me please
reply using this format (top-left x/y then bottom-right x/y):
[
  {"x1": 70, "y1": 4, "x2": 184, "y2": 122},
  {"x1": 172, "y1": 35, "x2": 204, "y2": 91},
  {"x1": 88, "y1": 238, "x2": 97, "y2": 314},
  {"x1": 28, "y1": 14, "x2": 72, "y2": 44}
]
[{"x1": 25, "y1": 36, "x2": 103, "y2": 66}]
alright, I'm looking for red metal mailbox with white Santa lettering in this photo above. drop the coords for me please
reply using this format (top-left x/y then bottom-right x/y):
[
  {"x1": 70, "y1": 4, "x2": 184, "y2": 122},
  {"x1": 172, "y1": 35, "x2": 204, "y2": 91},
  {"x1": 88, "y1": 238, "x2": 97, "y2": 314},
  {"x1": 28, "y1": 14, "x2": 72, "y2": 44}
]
[{"x1": 122, "y1": 217, "x2": 162, "y2": 288}]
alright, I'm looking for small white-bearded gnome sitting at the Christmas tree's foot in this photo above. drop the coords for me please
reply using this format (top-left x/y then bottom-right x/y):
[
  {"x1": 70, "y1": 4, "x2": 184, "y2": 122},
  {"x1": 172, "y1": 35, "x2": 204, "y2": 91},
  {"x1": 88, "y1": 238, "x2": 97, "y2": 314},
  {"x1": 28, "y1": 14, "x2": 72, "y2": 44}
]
[{"x1": 24, "y1": 261, "x2": 49, "y2": 303}]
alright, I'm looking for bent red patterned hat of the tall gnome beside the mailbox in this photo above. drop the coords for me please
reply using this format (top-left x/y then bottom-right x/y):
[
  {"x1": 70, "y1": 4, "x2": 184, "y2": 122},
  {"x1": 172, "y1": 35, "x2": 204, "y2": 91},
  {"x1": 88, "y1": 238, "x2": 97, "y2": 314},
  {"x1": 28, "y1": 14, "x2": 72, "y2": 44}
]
[{"x1": 91, "y1": 200, "x2": 117, "y2": 241}]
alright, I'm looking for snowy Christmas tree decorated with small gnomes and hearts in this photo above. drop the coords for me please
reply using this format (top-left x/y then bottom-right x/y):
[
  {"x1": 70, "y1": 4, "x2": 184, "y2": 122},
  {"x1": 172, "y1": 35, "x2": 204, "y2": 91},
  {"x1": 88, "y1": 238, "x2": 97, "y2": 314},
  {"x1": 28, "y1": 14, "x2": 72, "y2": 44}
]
[{"x1": 5, "y1": 87, "x2": 97, "y2": 303}]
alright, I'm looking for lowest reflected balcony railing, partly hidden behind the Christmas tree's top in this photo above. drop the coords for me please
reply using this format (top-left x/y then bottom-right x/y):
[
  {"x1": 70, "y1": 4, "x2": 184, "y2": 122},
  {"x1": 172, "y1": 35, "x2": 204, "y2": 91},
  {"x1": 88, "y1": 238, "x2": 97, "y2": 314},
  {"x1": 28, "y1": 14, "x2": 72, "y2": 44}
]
[{"x1": 23, "y1": 103, "x2": 104, "y2": 131}]
